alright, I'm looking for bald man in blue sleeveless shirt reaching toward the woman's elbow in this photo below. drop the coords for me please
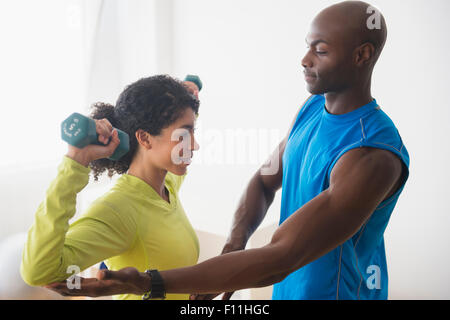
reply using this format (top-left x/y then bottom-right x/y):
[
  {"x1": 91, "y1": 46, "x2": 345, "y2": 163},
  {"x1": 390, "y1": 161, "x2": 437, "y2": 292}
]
[{"x1": 49, "y1": 1, "x2": 409, "y2": 299}]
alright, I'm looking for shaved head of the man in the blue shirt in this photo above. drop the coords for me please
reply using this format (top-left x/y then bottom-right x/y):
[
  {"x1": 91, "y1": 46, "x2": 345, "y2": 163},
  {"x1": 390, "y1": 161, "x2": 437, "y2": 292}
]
[{"x1": 302, "y1": 1, "x2": 387, "y2": 94}]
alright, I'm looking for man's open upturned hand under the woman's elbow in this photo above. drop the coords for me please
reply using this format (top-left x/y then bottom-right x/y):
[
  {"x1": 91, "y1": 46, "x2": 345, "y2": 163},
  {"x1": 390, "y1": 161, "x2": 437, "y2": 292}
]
[{"x1": 45, "y1": 267, "x2": 150, "y2": 297}]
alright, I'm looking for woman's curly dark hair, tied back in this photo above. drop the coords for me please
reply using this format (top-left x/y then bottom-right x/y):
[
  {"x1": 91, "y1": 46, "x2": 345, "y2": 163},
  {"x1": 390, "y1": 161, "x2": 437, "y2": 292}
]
[{"x1": 89, "y1": 75, "x2": 199, "y2": 181}]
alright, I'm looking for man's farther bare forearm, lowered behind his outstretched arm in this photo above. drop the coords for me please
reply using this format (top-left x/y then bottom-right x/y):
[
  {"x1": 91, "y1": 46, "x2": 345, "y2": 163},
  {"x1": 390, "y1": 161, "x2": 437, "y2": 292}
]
[{"x1": 227, "y1": 170, "x2": 275, "y2": 249}]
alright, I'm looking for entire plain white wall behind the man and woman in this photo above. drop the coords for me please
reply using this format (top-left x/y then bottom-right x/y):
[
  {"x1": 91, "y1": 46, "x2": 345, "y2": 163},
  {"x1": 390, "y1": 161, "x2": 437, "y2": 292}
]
[{"x1": 0, "y1": 0, "x2": 450, "y2": 299}]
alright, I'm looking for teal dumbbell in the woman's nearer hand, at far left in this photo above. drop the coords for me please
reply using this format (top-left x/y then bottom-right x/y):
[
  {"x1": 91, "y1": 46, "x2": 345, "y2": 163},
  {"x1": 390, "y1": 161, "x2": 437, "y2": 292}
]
[{"x1": 61, "y1": 112, "x2": 130, "y2": 161}]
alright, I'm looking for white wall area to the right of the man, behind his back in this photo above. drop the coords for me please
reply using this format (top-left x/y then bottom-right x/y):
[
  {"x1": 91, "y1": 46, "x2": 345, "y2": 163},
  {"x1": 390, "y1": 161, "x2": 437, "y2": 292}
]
[{"x1": 374, "y1": 0, "x2": 450, "y2": 299}]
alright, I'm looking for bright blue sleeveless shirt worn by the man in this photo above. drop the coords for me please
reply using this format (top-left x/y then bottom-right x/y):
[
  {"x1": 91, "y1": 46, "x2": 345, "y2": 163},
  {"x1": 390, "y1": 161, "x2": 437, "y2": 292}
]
[{"x1": 272, "y1": 95, "x2": 409, "y2": 300}]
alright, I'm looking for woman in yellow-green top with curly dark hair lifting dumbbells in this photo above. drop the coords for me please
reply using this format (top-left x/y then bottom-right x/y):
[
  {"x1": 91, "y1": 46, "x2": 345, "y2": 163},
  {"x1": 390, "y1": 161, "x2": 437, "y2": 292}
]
[{"x1": 21, "y1": 76, "x2": 199, "y2": 299}]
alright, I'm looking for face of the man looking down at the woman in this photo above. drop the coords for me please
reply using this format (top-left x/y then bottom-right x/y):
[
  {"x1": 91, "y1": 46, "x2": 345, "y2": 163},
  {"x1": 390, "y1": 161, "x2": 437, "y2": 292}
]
[{"x1": 302, "y1": 18, "x2": 355, "y2": 94}]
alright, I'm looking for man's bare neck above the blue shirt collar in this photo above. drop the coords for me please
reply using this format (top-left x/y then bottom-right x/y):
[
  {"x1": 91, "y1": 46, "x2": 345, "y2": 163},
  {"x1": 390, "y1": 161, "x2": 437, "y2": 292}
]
[{"x1": 325, "y1": 88, "x2": 373, "y2": 115}]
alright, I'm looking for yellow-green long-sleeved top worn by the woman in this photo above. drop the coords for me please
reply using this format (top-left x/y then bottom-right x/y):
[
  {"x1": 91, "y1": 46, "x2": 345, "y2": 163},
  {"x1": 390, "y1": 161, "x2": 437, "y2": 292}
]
[{"x1": 20, "y1": 156, "x2": 199, "y2": 299}]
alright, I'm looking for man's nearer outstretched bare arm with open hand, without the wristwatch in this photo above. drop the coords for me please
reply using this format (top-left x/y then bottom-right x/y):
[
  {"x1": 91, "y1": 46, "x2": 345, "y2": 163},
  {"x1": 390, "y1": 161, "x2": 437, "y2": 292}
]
[{"x1": 46, "y1": 148, "x2": 402, "y2": 296}]
